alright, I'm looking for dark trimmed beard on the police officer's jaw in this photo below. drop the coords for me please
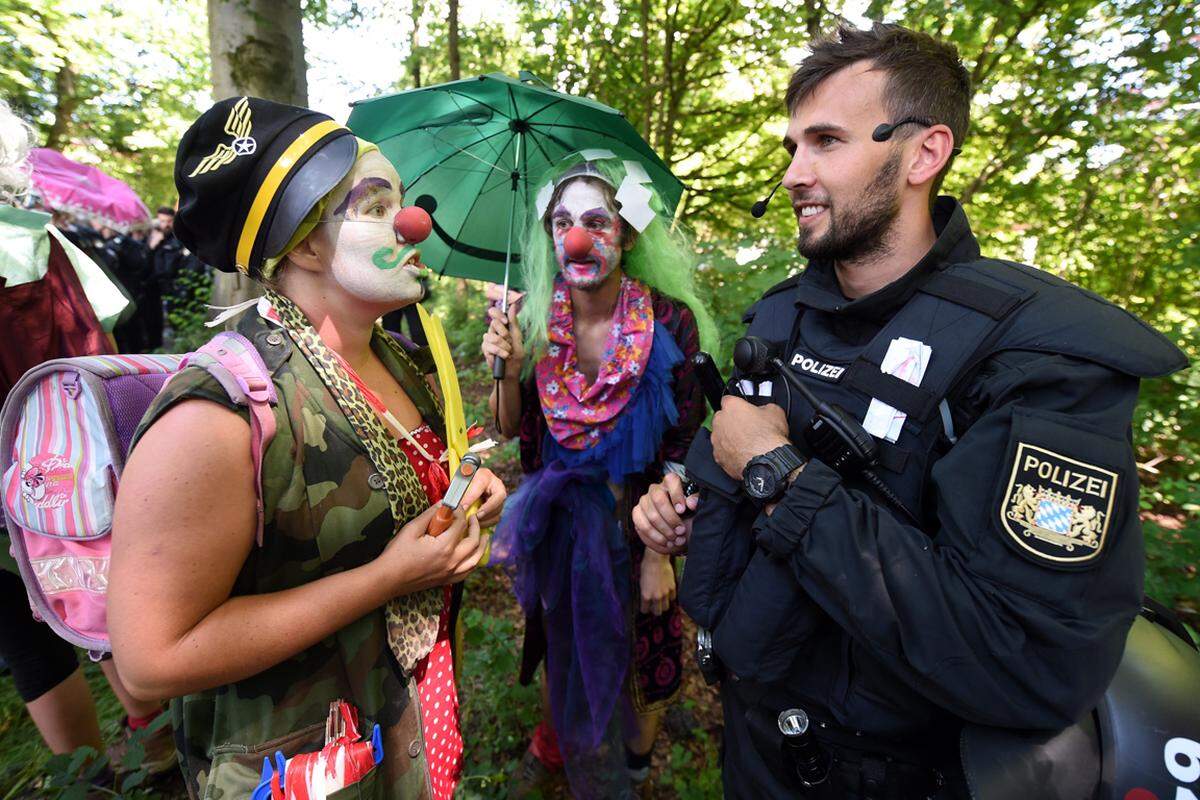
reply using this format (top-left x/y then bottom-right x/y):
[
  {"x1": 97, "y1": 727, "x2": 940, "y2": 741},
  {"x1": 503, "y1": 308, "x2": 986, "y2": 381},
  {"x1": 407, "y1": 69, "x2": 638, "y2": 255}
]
[{"x1": 796, "y1": 152, "x2": 900, "y2": 261}]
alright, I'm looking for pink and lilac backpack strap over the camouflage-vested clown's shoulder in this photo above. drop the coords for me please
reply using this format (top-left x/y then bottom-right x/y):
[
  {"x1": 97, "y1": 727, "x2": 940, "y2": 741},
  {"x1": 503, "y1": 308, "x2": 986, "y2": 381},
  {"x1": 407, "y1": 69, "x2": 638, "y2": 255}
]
[{"x1": 180, "y1": 331, "x2": 278, "y2": 547}]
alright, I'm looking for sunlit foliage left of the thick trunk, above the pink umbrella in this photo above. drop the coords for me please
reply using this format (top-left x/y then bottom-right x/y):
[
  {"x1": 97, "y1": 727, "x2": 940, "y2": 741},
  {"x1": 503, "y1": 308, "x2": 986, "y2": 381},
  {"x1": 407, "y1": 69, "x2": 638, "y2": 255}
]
[{"x1": 0, "y1": 0, "x2": 210, "y2": 210}]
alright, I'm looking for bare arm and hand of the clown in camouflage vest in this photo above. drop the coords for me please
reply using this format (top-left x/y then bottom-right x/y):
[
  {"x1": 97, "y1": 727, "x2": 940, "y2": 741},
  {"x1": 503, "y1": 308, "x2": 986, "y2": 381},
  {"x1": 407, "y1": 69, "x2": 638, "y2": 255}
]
[{"x1": 108, "y1": 401, "x2": 492, "y2": 698}]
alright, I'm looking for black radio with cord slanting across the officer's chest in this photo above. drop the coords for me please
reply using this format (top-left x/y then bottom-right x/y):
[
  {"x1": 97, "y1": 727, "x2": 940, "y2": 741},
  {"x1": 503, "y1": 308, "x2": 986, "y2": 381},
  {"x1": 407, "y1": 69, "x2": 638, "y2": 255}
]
[{"x1": 733, "y1": 336, "x2": 919, "y2": 524}]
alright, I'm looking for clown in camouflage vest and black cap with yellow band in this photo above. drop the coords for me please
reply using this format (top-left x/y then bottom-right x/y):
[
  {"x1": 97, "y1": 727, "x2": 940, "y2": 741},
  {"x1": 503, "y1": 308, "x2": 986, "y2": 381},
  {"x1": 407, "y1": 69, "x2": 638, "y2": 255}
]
[{"x1": 108, "y1": 97, "x2": 504, "y2": 800}]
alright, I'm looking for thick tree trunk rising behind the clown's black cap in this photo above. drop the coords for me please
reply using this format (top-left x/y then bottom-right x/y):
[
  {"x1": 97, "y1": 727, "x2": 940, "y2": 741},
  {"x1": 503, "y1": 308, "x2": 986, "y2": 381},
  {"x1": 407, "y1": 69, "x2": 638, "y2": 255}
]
[{"x1": 208, "y1": 0, "x2": 308, "y2": 306}]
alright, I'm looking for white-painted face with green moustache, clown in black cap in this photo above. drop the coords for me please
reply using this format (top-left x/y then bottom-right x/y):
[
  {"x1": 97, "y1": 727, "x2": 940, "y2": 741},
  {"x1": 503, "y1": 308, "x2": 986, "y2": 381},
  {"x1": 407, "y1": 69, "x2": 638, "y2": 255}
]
[{"x1": 323, "y1": 151, "x2": 424, "y2": 308}]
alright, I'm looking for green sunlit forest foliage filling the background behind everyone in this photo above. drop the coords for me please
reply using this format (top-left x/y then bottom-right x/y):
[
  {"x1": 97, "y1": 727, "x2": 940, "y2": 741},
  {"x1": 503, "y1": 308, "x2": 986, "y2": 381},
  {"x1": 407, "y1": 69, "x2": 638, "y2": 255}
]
[{"x1": 0, "y1": 0, "x2": 1200, "y2": 796}]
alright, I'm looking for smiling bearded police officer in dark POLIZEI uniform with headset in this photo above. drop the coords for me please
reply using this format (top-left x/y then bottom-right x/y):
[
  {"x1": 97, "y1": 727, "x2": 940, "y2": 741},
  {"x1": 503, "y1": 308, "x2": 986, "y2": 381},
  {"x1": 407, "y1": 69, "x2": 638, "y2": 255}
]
[{"x1": 634, "y1": 25, "x2": 1186, "y2": 799}]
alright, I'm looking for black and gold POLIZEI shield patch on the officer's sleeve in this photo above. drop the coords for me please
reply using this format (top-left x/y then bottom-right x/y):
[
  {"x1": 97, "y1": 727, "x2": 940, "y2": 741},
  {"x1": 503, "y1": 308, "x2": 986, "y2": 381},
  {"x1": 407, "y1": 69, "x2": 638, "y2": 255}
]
[{"x1": 1000, "y1": 443, "x2": 1117, "y2": 566}]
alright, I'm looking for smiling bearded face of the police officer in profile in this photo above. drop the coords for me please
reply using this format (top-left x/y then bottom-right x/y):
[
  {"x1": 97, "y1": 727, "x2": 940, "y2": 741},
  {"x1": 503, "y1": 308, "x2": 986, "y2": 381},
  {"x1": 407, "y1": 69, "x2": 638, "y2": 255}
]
[{"x1": 784, "y1": 62, "x2": 901, "y2": 261}]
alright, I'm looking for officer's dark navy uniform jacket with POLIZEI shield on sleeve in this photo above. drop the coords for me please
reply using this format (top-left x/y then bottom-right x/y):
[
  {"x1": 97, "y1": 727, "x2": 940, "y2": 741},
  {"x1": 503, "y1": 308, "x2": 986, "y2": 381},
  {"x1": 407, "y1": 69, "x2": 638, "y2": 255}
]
[{"x1": 680, "y1": 198, "x2": 1187, "y2": 796}]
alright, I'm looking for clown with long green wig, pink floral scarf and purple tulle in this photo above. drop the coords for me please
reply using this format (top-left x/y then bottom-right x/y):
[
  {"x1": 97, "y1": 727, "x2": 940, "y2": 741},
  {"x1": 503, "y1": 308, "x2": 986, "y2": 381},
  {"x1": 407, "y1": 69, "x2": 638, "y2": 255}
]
[{"x1": 482, "y1": 150, "x2": 715, "y2": 798}]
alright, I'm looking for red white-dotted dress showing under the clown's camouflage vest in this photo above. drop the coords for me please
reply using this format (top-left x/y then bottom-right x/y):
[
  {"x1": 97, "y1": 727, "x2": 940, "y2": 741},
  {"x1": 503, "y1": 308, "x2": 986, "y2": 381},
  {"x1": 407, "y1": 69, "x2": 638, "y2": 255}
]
[{"x1": 400, "y1": 425, "x2": 462, "y2": 800}]
